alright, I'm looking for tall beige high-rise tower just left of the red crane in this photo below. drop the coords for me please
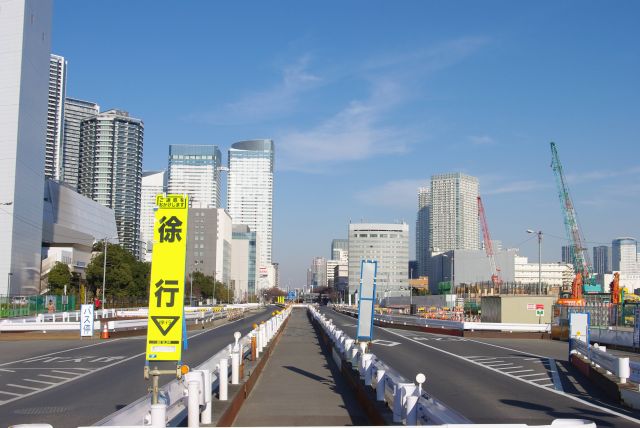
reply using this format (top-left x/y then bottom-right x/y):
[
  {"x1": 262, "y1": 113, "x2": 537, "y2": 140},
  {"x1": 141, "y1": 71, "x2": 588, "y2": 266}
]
[{"x1": 429, "y1": 173, "x2": 480, "y2": 251}]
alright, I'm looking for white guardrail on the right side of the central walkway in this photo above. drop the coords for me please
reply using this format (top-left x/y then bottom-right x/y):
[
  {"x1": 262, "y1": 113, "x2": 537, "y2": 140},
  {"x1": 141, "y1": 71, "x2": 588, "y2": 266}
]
[{"x1": 309, "y1": 306, "x2": 596, "y2": 428}]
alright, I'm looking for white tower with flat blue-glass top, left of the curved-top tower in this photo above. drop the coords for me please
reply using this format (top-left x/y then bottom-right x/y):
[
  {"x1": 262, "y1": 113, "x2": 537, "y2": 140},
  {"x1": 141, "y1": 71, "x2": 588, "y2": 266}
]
[{"x1": 167, "y1": 144, "x2": 221, "y2": 208}]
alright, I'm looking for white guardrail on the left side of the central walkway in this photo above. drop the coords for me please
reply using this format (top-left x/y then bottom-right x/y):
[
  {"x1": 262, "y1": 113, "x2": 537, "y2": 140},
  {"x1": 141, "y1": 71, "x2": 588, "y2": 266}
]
[{"x1": 85, "y1": 309, "x2": 291, "y2": 428}]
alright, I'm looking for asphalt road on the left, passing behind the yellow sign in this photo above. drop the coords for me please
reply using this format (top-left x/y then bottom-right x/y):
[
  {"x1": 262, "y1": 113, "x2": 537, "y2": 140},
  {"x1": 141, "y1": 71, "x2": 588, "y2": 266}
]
[{"x1": 0, "y1": 308, "x2": 273, "y2": 428}]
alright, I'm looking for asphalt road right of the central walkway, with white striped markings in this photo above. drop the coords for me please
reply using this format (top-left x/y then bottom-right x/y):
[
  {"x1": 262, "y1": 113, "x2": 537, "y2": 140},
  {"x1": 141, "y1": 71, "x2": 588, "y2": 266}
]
[{"x1": 321, "y1": 308, "x2": 640, "y2": 427}]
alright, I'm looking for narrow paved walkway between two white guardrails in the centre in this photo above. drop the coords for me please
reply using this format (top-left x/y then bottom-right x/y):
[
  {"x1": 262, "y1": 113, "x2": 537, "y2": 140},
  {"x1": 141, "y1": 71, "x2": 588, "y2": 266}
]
[{"x1": 234, "y1": 309, "x2": 369, "y2": 427}]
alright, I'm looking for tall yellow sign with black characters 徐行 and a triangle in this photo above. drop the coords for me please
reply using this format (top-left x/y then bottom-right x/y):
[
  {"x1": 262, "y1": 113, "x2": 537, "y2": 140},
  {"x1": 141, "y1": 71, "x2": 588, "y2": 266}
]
[{"x1": 147, "y1": 195, "x2": 189, "y2": 361}]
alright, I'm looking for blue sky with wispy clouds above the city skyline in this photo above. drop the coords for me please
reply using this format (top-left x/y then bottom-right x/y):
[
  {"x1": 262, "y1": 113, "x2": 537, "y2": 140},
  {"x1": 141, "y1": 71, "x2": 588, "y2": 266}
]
[{"x1": 52, "y1": 0, "x2": 640, "y2": 286}]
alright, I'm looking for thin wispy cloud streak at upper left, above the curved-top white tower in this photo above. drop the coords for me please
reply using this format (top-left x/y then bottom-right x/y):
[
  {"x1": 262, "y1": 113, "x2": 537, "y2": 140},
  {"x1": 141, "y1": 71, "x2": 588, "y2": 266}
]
[{"x1": 190, "y1": 56, "x2": 322, "y2": 125}]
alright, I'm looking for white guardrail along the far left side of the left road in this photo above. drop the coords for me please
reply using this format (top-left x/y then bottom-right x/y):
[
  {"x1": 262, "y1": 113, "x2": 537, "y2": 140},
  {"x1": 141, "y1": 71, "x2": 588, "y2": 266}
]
[{"x1": 0, "y1": 304, "x2": 258, "y2": 333}]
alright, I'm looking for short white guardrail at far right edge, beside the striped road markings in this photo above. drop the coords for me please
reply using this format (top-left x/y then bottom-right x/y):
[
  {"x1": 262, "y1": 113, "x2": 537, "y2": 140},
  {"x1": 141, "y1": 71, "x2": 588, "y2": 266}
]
[{"x1": 570, "y1": 339, "x2": 640, "y2": 383}]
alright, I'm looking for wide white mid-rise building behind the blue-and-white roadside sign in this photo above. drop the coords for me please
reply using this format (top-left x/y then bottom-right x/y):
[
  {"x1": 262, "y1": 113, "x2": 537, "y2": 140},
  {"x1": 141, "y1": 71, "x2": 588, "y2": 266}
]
[{"x1": 349, "y1": 223, "x2": 409, "y2": 297}]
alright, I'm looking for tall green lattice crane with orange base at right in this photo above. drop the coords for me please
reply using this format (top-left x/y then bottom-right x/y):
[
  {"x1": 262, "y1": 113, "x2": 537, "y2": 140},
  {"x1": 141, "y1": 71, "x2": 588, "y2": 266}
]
[{"x1": 551, "y1": 142, "x2": 602, "y2": 299}]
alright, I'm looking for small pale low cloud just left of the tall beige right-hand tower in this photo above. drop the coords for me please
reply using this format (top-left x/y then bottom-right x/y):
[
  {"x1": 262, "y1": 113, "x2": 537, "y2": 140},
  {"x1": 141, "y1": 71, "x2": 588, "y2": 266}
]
[{"x1": 356, "y1": 178, "x2": 431, "y2": 210}]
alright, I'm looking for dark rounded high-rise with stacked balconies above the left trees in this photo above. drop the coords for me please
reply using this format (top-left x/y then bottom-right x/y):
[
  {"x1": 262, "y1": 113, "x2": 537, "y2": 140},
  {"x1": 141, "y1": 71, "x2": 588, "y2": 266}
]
[{"x1": 78, "y1": 110, "x2": 144, "y2": 258}]
